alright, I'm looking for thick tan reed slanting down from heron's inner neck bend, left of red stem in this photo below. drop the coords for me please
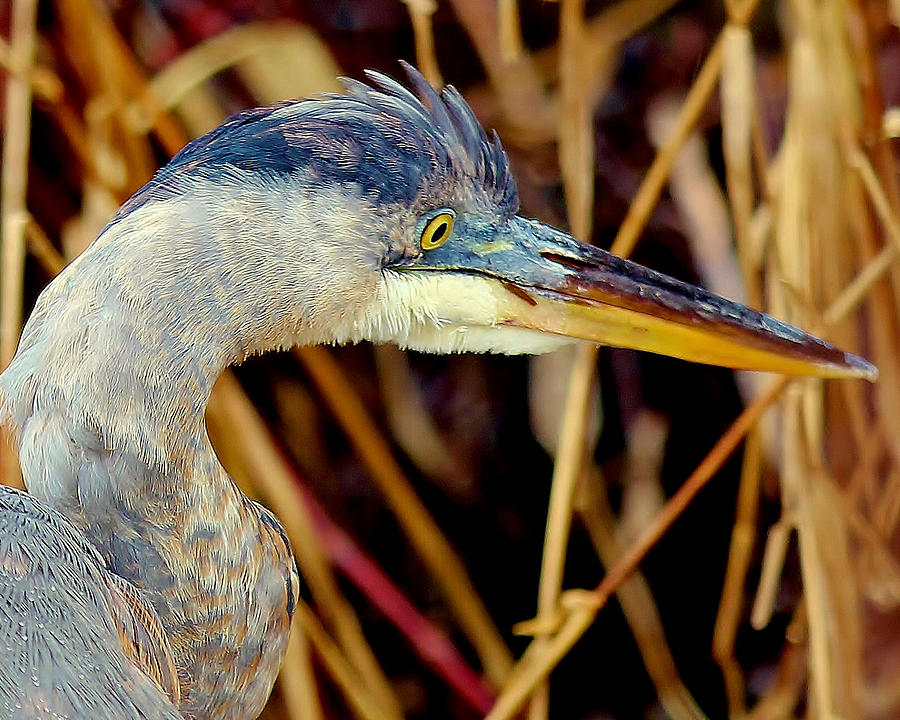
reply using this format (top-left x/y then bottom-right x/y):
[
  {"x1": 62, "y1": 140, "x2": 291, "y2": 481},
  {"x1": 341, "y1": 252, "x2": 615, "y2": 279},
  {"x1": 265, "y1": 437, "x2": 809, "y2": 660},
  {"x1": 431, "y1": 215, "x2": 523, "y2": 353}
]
[{"x1": 207, "y1": 372, "x2": 403, "y2": 718}]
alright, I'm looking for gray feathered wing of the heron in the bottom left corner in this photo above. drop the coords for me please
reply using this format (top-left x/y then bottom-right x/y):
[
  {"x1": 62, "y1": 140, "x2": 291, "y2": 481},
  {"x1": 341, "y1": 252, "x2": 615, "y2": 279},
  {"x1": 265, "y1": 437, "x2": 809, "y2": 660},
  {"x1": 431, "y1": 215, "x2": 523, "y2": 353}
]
[{"x1": 0, "y1": 486, "x2": 183, "y2": 720}]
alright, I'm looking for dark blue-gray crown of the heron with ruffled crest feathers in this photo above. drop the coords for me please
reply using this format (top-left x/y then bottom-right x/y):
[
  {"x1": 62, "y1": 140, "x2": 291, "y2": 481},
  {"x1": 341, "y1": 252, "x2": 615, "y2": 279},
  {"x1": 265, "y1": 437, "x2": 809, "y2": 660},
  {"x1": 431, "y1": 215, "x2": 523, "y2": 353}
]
[{"x1": 117, "y1": 63, "x2": 519, "y2": 219}]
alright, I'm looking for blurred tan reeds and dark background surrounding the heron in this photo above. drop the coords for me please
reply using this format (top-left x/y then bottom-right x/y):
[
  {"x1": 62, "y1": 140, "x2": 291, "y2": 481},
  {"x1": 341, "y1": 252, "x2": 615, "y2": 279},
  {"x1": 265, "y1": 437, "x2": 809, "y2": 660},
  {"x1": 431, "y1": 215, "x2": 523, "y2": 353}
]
[{"x1": 0, "y1": 0, "x2": 900, "y2": 720}]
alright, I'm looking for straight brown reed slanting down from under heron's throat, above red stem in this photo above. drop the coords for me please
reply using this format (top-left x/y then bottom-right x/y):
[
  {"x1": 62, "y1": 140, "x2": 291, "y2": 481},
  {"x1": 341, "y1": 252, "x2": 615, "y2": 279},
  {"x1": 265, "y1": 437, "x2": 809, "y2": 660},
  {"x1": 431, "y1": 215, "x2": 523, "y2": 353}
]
[{"x1": 295, "y1": 347, "x2": 512, "y2": 687}]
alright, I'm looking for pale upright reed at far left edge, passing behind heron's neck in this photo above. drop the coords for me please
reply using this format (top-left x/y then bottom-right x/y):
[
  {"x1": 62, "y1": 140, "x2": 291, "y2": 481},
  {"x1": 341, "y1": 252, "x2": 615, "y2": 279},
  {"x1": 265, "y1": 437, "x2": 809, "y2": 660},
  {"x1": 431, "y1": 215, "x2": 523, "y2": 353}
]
[{"x1": 0, "y1": 0, "x2": 37, "y2": 488}]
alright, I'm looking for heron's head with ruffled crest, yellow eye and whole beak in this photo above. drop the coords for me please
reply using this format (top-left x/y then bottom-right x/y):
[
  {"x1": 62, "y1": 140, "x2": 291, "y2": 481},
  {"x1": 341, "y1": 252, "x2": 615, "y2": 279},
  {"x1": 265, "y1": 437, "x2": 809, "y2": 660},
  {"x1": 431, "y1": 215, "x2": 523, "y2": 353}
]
[{"x1": 120, "y1": 68, "x2": 876, "y2": 378}]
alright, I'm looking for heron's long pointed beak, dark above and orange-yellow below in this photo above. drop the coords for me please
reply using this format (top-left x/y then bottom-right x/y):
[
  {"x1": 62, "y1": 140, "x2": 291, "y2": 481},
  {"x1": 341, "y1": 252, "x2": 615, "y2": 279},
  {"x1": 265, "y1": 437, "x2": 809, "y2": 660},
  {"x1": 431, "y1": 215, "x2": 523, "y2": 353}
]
[{"x1": 398, "y1": 217, "x2": 878, "y2": 381}]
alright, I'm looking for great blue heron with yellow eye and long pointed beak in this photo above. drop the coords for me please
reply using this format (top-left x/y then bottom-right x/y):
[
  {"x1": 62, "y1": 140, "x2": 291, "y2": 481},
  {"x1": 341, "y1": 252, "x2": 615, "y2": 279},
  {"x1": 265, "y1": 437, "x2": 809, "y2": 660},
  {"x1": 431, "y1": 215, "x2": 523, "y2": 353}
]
[{"x1": 0, "y1": 64, "x2": 875, "y2": 719}]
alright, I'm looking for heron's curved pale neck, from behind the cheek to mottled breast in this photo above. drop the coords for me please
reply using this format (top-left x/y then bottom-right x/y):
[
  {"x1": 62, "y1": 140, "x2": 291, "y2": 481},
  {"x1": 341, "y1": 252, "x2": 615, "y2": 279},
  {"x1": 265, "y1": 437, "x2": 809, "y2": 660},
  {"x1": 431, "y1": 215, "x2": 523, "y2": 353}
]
[{"x1": 0, "y1": 183, "x2": 315, "y2": 718}]
